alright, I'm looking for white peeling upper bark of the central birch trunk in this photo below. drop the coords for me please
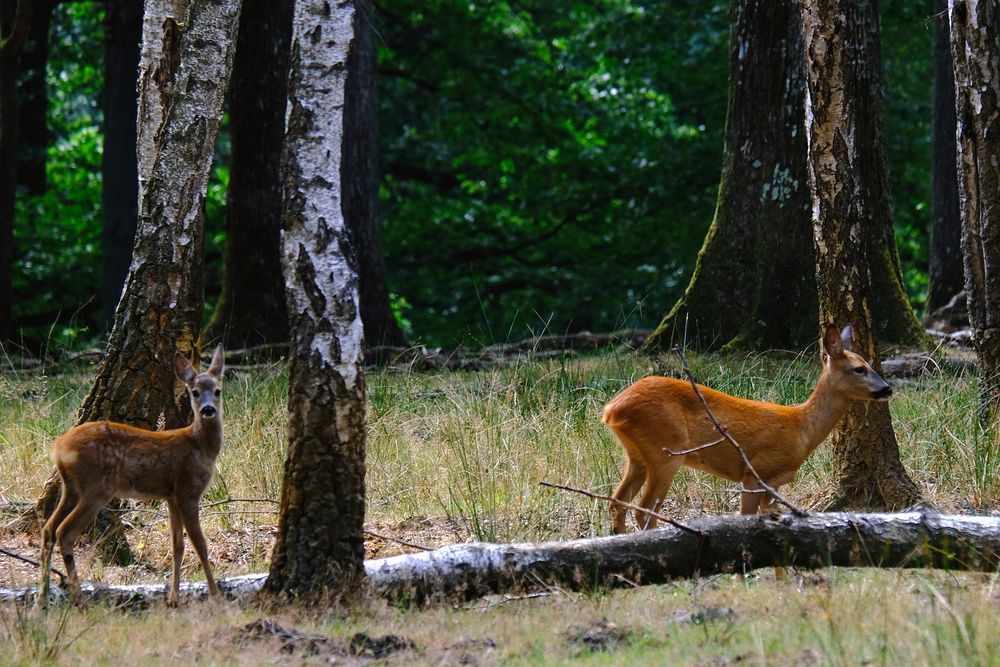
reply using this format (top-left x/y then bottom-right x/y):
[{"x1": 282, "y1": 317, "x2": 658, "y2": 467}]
[{"x1": 282, "y1": 0, "x2": 363, "y2": 388}]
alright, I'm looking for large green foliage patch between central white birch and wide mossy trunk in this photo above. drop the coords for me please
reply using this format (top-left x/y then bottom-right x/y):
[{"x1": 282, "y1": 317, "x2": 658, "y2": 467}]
[{"x1": 379, "y1": 0, "x2": 728, "y2": 343}]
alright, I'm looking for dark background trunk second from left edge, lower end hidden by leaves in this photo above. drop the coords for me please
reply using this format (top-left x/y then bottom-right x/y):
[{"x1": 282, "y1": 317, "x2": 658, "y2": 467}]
[{"x1": 17, "y1": 0, "x2": 56, "y2": 195}]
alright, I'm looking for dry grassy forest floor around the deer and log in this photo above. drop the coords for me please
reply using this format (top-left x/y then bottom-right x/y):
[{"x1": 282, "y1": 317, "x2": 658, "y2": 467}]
[{"x1": 0, "y1": 342, "x2": 1000, "y2": 665}]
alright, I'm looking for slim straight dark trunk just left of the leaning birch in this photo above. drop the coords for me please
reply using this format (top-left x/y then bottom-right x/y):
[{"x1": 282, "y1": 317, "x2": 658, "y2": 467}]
[{"x1": 101, "y1": 0, "x2": 142, "y2": 328}]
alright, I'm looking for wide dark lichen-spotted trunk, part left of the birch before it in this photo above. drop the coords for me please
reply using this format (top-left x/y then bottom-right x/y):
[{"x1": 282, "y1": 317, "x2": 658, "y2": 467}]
[{"x1": 644, "y1": 0, "x2": 816, "y2": 351}]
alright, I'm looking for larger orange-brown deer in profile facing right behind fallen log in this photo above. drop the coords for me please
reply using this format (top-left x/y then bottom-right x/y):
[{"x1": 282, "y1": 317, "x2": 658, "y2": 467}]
[{"x1": 601, "y1": 324, "x2": 892, "y2": 533}]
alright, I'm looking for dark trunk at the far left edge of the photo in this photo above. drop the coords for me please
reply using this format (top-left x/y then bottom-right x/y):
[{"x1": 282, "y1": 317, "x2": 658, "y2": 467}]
[{"x1": 0, "y1": 0, "x2": 33, "y2": 343}]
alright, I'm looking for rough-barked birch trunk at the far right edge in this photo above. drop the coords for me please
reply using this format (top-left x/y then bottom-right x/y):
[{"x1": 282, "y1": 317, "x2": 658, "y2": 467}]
[{"x1": 948, "y1": 0, "x2": 1000, "y2": 426}]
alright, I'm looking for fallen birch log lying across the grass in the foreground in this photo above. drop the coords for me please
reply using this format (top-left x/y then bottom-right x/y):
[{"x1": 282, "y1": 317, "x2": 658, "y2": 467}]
[{"x1": 0, "y1": 512, "x2": 1000, "y2": 606}]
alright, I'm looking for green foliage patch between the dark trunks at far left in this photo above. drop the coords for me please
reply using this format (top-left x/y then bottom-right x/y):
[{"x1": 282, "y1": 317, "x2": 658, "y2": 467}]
[{"x1": 12, "y1": 2, "x2": 104, "y2": 350}]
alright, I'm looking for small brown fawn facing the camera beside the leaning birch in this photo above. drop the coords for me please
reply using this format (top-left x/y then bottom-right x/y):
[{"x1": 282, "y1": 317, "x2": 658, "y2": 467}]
[{"x1": 41, "y1": 345, "x2": 224, "y2": 605}]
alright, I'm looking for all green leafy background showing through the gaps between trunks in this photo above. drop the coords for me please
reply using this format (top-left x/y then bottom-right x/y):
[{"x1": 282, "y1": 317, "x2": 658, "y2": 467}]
[{"x1": 14, "y1": 0, "x2": 933, "y2": 345}]
